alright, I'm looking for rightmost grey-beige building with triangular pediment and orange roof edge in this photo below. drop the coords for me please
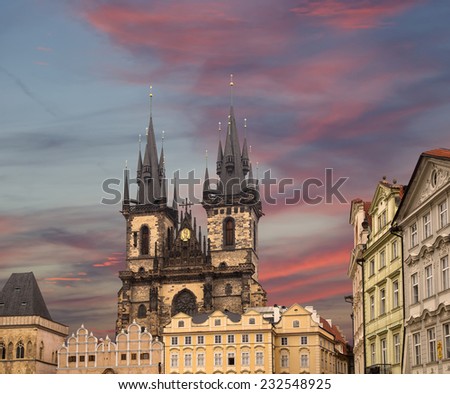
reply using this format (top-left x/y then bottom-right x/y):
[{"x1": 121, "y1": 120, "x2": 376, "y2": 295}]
[{"x1": 393, "y1": 149, "x2": 450, "y2": 374}]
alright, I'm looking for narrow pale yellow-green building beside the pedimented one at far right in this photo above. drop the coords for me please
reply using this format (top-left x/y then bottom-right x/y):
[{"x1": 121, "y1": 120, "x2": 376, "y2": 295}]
[{"x1": 362, "y1": 180, "x2": 404, "y2": 373}]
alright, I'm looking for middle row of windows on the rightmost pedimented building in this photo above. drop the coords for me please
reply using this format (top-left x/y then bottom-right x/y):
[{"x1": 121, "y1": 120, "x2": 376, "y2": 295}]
[{"x1": 411, "y1": 255, "x2": 450, "y2": 304}]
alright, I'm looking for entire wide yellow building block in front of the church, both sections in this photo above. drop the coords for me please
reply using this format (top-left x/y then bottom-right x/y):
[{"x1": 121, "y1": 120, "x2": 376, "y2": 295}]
[{"x1": 163, "y1": 304, "x2": 348, "y2": 374}]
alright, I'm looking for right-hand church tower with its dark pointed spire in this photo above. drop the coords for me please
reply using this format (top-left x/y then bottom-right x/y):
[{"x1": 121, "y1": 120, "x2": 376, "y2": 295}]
[{"x1": 203, "y1": 82, "x2": 266, "y2": 313}]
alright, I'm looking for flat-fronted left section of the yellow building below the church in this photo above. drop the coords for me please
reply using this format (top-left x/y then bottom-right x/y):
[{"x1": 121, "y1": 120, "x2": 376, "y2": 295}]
[{"x1": 163, "y1": 310, "x2": 273, "y2": 374}]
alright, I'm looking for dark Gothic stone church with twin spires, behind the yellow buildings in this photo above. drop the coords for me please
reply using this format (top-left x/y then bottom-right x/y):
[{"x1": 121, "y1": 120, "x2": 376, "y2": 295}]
[{"x1": 116, "y1": 88, "x2": 266, "y2": 335}]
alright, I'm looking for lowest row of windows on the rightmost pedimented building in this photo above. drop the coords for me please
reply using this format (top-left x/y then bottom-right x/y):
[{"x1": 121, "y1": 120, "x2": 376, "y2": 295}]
[{"x1": 412, "y1": 323, "x2": 450, "y2": 365}]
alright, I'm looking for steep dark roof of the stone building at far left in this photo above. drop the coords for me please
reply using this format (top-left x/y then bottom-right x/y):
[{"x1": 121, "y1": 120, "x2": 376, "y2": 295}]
[{"x1": 0, "y1": 272, "x2": 52, "y2": 320}]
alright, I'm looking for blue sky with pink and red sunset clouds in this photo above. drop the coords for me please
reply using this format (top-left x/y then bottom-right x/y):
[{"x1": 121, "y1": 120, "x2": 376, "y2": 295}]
[{"x1": 0, "y1": 0, "x2": 450, "y2": 339}]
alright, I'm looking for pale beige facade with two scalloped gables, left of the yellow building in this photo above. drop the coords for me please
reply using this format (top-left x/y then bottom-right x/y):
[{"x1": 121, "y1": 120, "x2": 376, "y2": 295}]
[{"x1": 57, "y1": 323, "x2": 164, "y2": 374}]
